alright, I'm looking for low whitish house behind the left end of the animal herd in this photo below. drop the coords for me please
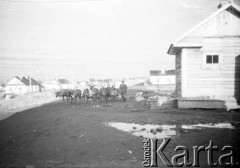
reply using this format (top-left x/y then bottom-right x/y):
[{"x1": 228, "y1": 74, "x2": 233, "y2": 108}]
[{"x1": 43, "y1": 79, "x2": 74, "y2": 90}]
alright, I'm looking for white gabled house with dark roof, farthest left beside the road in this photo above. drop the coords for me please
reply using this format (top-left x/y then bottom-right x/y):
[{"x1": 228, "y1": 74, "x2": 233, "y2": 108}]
[{"x1": 5, "y1": 76, "x2": 41, "y2": 95}]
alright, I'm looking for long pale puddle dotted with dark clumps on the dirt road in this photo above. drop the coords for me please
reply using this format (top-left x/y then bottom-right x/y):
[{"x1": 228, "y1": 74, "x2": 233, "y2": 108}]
[{"x1": 105, "y1": 122, "x2": 234, "y2": 139}]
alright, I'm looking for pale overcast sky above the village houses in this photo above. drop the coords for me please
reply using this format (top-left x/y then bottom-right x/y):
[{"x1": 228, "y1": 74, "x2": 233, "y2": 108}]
[{"x1": 0, "y1": 0, "x2": 239, "y2": 82}]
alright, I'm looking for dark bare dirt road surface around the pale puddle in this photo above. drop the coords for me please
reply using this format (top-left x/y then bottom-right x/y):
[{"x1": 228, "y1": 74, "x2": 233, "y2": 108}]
[{"x1": 0, "y1": 100, "x2": 240, "y2": 167}]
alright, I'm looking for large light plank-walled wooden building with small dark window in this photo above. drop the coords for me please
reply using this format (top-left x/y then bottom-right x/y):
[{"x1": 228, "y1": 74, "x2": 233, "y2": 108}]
[{"x1": 168, "y1": 1, "x2": 240, "y2": 109}]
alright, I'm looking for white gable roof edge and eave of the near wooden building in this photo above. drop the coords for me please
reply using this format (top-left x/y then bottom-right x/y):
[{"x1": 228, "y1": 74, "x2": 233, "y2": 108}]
[{"x1": 167, "y1": 2, "x2": 240, "y2": 55}]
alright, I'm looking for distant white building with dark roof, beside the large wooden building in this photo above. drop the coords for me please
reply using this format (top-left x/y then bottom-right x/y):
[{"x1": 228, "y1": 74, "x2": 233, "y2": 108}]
[{"x1": 149, "y1": 70, "x2": 176, "y2": 85}]
